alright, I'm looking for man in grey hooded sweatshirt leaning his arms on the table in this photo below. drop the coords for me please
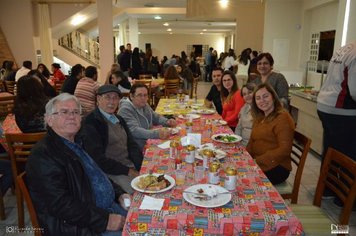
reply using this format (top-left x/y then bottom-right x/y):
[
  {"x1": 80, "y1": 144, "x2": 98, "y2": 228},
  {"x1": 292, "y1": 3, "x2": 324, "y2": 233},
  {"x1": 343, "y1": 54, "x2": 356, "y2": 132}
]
[{"x1": 119, "y1": 83, "x2": 177, "y2": 151}]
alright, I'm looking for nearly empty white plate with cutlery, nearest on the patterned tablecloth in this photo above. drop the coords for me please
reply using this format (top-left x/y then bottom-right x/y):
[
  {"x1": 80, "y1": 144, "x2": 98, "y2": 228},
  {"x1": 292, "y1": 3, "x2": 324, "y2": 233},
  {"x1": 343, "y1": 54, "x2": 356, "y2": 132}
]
[{"x1": 183, "y1": 184, "x2": 232, "y2": 208}]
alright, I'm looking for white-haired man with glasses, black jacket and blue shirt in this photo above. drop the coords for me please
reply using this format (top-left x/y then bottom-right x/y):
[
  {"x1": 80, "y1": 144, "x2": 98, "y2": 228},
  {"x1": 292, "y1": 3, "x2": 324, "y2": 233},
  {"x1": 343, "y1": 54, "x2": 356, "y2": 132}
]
[{"x1": 26, "y1": 93, "x2": 130, "y2": 235}]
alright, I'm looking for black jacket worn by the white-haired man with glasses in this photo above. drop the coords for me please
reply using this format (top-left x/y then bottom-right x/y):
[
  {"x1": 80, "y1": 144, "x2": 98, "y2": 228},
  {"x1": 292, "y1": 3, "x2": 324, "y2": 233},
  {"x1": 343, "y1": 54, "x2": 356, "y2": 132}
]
[{"x1": 26, "y1": 128, "x2": 123, "y2": 236}]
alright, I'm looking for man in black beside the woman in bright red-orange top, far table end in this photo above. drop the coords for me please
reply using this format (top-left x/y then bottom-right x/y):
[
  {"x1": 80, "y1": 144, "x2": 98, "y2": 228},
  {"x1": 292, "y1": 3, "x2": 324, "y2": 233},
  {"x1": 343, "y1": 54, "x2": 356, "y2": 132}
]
[{"x1": 204, "y1": 67, "x2": 224, "y2": 115}]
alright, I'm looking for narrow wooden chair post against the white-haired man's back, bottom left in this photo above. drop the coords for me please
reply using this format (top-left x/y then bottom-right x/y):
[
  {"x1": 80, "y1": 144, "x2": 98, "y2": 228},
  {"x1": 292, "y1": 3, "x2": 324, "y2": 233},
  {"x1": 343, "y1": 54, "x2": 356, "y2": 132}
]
[{"x1": 16, "y1": 172, "x2": 42, "y2": 236}]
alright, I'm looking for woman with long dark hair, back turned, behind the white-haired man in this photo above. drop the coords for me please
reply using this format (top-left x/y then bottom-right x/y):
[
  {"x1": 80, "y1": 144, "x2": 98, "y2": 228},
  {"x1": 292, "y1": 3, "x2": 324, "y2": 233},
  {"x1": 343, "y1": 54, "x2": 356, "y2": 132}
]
[{"x1": 14, "y1": 75, "x2": 48, "y2": 133}]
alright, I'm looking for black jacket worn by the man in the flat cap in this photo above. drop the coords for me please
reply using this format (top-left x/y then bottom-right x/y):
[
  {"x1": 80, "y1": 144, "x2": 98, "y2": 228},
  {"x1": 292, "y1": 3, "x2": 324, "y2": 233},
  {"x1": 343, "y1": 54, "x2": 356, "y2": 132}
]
[{"x1": 81, "y1": 108, "x2": 143, "y2": 175}]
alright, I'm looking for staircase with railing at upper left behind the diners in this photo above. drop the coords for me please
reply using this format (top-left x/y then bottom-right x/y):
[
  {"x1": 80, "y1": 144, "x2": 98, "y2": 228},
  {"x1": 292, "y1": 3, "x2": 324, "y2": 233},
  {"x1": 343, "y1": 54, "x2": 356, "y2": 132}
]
[{"x1": 58, "y1": 31, "x2": 100, "y2": 68}]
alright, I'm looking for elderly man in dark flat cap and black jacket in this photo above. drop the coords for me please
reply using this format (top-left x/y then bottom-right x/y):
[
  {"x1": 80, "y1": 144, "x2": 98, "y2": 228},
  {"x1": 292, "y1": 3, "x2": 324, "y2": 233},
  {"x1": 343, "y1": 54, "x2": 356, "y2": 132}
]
[{"x1": 82, "y1": 84, "x2": 143, "y2": 193}]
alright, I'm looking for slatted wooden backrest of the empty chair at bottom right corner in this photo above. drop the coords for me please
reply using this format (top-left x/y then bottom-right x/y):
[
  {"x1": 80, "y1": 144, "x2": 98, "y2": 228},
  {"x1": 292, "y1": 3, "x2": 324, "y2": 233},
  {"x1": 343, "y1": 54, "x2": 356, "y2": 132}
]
[{"x1": 314, "y1": 147, "x2": 356, "y2": 225}]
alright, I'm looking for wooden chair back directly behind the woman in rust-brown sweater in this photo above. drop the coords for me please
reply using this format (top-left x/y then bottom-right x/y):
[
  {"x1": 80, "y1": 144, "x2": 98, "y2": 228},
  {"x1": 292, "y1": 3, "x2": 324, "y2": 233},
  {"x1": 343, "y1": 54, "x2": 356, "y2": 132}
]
[{"x1": 291, "y1": 131, "x2": 311, "y2": 203}]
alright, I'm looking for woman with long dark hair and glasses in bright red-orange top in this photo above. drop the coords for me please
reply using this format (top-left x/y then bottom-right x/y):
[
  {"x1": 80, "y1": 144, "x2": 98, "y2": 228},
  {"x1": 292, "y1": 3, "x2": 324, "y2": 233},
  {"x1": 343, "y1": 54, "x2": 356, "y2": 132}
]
[{"x1": 220, "y1": 70, "x2": 245, "y2": 131}]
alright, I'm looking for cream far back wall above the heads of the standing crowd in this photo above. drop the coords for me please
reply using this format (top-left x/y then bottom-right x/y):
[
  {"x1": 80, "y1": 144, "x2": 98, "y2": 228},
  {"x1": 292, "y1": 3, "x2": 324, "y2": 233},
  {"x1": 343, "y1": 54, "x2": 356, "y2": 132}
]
[{"x1": 139, "y1": 34, "x2": 225, "y2": 59}]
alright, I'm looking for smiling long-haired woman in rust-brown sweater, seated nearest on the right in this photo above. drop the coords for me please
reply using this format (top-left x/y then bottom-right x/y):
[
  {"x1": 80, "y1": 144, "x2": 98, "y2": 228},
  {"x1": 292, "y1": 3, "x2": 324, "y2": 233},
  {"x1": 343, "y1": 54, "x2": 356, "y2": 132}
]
[{"x1": 246, "y1": 83, "x2": 295, "y2": 184}]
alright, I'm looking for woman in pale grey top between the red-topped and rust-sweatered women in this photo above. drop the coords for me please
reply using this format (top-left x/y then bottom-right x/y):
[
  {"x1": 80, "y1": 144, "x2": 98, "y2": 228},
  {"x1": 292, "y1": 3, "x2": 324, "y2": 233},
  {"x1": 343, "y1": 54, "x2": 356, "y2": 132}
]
[{"x1": 235, "y1": 83, "x2": 256, "y2": 146}]
